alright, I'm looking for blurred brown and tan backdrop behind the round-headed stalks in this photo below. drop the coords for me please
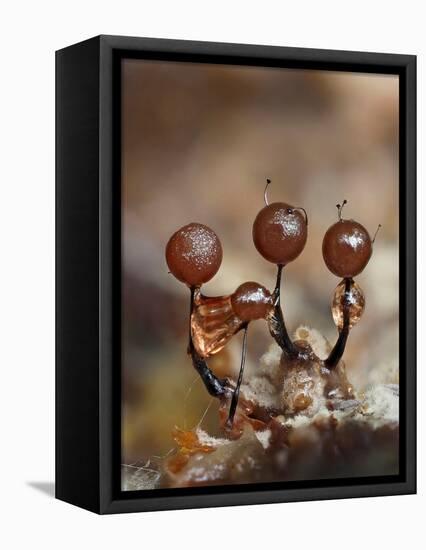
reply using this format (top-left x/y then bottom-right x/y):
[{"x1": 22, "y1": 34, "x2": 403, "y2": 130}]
[{"x1": 122, "y1": 60, "x2": 398, "y2": 476}]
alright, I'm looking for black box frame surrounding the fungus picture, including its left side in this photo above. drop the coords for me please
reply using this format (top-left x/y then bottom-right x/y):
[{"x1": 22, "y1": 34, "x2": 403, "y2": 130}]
[{"x1": 56, "y1": 36, "x2": 416, "y2": 514}]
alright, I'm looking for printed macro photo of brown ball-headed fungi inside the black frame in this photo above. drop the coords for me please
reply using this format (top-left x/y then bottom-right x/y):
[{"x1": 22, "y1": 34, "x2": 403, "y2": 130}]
[{"x1": 121, "y1": 59, "x2": 399, "y2": 491}]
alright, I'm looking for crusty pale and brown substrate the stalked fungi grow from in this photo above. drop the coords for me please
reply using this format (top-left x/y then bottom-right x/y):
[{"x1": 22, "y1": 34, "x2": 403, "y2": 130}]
[{"x1": 125, "y1": 326, "x2": 399, "y2": 489}]
